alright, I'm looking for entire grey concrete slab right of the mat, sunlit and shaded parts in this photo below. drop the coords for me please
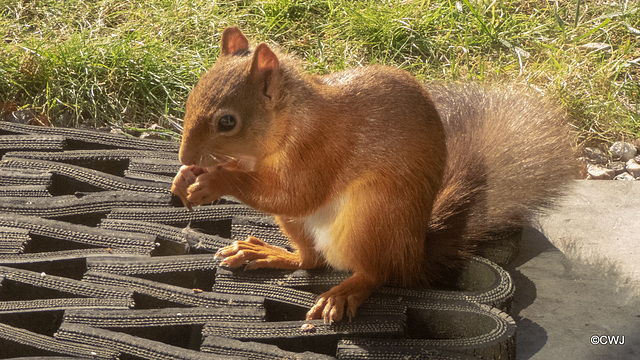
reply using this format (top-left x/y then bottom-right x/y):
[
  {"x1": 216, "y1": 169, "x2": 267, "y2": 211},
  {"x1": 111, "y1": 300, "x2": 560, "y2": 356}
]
[{"x1": 509, "y1": 181, "x2": 640, "y2": 359}]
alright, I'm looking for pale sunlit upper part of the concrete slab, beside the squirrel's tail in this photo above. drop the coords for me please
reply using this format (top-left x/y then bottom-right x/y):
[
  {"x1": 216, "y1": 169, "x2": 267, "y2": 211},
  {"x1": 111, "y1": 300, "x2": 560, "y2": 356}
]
[{"x1": 537, "y1": 181, "x2": 640, "y2": 285}]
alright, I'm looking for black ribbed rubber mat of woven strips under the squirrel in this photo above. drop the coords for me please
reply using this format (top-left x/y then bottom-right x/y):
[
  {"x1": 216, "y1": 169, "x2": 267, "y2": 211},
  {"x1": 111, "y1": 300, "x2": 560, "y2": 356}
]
[{"x1": 0, "y1": 122, "x2": 515, "y2": 360}]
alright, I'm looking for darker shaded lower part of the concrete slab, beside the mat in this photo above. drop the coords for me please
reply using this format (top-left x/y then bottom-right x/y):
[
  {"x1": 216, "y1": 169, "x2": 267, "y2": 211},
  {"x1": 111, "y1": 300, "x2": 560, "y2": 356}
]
[{"x1": 506, "y1": 228, "x2": 640, "y2": 359}]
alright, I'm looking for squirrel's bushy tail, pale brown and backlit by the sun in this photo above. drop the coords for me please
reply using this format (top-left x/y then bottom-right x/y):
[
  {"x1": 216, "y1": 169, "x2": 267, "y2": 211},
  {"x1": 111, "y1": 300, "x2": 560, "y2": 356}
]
[{"x1": 424, "y1": 84, "x2": 577, "y2": 282}]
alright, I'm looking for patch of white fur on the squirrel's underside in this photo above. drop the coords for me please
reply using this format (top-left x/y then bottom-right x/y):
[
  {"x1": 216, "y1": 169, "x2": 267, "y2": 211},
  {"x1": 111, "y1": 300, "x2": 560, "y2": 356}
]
[{"x1": 304, "y1": 196, "x2": 347, "y2": 268}]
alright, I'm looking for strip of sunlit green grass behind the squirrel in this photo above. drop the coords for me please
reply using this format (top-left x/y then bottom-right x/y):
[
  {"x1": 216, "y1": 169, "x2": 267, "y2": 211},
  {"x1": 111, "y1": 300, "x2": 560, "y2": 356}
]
[{"x1": 0, "y1": 0, "x2": 640, "y2": 142}]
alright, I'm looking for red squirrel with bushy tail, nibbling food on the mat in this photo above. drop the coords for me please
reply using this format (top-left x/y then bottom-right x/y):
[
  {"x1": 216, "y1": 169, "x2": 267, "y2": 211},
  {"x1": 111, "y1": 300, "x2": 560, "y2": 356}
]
[{"x1": 172, "y1": 27, "x2": 572, "y2": 321}]
